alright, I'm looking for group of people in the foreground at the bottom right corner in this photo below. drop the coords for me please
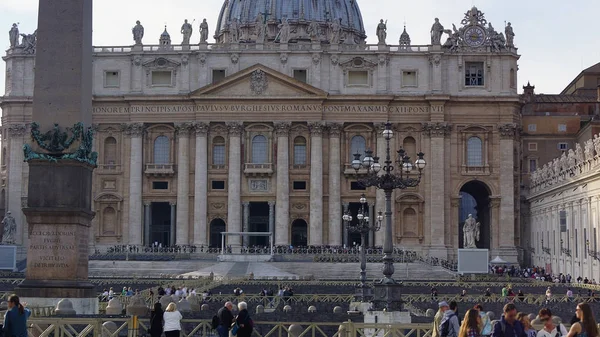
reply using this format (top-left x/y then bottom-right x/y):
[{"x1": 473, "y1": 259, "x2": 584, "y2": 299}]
[{"x1": 431, "y1": 301, "x2": 599, "y2": 337}]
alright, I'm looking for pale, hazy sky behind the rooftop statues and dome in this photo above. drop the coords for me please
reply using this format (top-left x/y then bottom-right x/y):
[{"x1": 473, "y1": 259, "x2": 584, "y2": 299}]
[{"x1": 0, "y1": 0, "x2": 600, "y2": 94}]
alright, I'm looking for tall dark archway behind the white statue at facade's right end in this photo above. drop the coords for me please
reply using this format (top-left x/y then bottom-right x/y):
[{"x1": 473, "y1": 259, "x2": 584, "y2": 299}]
[{"x1": 458, "y1": 180, "x2": 492, "y2": 248}]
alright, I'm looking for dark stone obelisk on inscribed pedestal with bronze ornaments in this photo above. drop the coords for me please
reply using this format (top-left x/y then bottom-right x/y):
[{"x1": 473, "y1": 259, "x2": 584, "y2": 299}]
[{"x1": 16, "y1": 0, "x2": 98, "y2": 314}]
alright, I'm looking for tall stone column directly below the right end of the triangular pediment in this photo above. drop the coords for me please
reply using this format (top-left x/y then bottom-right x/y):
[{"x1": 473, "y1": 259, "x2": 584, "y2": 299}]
[{"x1": 308, "y1": 122, "x2": 323, "y2": 246}]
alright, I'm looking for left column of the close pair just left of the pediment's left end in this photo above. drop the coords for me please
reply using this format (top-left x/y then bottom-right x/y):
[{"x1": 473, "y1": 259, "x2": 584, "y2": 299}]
[{"x1": 175, "y1": 123, "x2": 192, "y2": 245}]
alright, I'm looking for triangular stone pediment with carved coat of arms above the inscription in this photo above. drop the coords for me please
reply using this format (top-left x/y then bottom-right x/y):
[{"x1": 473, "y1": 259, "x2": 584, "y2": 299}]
[{"x1": 190, "y1": 64, "x2": 328, "y2": 99}]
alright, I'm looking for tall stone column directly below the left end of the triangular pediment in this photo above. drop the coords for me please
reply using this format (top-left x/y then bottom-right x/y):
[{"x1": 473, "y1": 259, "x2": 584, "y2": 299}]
[{"x1": 194, "y1": 123, "x2": 208, "y2": 246}]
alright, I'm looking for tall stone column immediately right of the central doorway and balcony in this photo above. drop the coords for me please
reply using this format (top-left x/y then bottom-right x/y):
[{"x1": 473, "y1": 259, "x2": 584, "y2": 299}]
[{"x1": 269, "y1": 123, "x2": 292, "y2": 246}]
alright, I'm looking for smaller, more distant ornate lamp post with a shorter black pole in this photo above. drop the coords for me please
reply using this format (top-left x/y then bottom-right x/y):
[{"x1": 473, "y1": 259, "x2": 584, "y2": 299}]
[{"x1": 342, "y1": 194, "x2": 383, "y2": 302}]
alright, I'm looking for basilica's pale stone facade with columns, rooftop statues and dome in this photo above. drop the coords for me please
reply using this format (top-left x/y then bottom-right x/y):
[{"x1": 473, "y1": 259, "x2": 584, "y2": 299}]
[{"x1": 0, "y1": 0, "x2": 520, "y2": 261}]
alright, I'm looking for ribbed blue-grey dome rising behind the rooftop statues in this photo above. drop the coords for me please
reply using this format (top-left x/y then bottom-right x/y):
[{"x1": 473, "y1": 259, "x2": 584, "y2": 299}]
[{"x1": 215, "y1": 0, "x2": 366, "y2": 44}]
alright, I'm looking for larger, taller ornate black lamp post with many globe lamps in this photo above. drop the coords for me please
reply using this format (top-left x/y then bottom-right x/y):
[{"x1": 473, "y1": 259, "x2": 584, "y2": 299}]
[{"x1": 351, "y1": 122, "x2": 427, "y2": 311}]
